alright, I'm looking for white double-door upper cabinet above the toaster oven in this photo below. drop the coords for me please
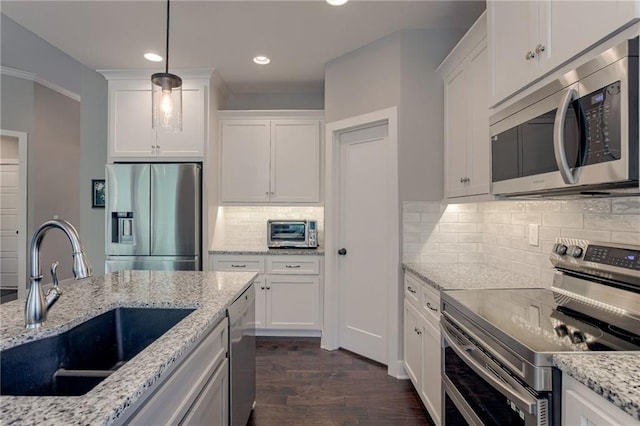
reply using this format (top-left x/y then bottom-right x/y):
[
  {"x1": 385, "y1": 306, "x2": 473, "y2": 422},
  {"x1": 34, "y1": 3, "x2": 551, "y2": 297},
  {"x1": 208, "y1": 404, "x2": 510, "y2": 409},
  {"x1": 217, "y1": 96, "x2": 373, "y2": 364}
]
[{"x1": 220, "y1": 112, "x2": 321, "y2": 203}]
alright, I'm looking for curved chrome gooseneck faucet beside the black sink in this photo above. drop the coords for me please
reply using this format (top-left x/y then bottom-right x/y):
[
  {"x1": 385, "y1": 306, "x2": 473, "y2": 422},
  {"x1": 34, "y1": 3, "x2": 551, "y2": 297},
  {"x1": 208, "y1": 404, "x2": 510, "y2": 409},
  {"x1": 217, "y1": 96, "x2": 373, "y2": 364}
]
[{"x1": 24, "y1": 219, "x2": 92, "y2": 328}]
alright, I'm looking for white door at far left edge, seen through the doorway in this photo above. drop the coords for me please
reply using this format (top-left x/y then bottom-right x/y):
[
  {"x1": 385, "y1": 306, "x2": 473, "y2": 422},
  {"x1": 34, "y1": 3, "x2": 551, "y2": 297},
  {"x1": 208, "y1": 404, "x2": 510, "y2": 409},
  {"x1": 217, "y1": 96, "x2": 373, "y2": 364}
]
[{"x1": 0, "y1": 164, "x2": 20, "y2": 289}]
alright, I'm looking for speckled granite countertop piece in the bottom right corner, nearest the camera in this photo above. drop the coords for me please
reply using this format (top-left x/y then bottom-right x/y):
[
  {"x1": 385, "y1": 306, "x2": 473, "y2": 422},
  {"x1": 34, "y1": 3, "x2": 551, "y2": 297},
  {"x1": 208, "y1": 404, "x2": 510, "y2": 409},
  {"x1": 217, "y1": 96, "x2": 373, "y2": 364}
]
[{"x1": 553, "y1": 352, "x2": 640, "y2": 420}]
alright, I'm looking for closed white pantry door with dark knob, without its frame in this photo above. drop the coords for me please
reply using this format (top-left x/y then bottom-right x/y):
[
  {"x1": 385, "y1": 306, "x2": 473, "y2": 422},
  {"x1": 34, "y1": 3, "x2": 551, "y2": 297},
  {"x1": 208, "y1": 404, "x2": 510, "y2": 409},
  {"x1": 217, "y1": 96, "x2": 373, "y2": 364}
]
[{"x1": 337, "y1": 124, "x2": 390, "y2": 364}]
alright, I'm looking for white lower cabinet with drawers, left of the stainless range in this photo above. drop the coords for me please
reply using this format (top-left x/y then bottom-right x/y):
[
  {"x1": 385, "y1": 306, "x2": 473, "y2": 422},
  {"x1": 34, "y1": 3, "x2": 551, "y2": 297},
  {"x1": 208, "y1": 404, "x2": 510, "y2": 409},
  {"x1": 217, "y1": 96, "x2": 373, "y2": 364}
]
[{"x1": 404, "y1": 271, "x2": 442, "y2": 425}]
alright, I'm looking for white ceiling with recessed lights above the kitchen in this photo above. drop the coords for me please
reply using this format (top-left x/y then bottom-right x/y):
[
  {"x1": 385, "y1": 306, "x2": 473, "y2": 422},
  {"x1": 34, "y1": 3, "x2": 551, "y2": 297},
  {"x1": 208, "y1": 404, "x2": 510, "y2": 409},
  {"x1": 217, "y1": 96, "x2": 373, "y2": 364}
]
[{"x1": 0, "y1": 0, "x2": 485, "y2": 93}]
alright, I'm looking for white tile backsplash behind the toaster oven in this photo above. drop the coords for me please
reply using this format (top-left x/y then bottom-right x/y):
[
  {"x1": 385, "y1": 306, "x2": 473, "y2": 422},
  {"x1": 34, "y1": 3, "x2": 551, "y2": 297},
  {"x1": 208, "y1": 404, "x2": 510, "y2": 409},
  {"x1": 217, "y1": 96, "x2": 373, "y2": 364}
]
[{"x1": 216, "y1": 206, "x2": 324, "y2": 248}]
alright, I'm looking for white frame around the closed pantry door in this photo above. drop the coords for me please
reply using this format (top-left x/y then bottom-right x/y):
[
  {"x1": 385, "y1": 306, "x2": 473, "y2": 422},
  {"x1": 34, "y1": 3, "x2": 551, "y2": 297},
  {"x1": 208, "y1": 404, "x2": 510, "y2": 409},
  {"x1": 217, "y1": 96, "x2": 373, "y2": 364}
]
[{"x1": 320, "y1": 106, "x2": 404, "y2": 377}]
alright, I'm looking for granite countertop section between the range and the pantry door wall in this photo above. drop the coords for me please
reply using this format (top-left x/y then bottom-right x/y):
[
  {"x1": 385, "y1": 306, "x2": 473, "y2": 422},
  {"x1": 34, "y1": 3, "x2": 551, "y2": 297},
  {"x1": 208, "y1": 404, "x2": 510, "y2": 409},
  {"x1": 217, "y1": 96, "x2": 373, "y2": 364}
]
[{"x1": 402, "y1": 263, "x2": 551, "y2": 290}]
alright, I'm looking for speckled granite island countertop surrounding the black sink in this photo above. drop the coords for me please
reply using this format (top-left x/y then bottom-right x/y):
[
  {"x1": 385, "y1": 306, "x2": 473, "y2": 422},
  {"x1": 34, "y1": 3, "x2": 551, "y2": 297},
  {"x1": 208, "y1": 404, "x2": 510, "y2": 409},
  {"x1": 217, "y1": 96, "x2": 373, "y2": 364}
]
[{"x1": 0, "y1": 271, "x2": 256, "y2": 425}]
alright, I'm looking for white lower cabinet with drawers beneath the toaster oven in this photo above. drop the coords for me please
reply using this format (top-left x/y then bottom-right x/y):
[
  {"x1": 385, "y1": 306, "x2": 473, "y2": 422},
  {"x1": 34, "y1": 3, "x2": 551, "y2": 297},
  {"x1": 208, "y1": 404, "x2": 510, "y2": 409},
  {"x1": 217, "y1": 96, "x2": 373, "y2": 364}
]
[{"x1": 210, "y1": 254, "x2": 322, "y2": 336}]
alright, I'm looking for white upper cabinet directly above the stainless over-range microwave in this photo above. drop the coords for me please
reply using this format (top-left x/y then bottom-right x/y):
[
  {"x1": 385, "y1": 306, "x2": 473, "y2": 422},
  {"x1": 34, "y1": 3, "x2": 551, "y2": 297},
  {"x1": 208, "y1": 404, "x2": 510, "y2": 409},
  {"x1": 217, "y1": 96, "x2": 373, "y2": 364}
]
[{"x1": 487, "y1": 0, "x2": 640, "y2": 105}]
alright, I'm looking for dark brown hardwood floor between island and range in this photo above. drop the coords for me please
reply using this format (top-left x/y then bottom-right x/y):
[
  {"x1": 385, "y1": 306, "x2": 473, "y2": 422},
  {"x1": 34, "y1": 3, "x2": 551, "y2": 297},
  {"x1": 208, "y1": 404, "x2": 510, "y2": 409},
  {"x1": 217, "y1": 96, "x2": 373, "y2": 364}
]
[{"x1": 248, "y1": 337, "x2": 434, "y2": 426}]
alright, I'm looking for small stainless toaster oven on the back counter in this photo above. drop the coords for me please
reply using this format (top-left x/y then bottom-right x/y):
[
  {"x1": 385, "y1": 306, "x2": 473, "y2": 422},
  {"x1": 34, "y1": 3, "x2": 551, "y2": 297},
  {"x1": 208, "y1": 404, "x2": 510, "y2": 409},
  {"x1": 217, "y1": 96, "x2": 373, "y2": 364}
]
[{"x1": 267, "y1": 219, "x2": 318, "y2": 248}]
